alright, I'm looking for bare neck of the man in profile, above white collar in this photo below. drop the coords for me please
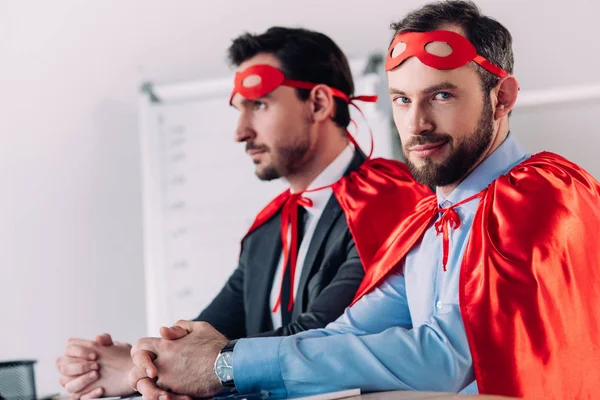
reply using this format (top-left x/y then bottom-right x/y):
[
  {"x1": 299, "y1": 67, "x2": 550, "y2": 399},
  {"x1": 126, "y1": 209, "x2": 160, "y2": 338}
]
[{"x1": 285, "y1": 127, "x2": 348, "y2": 193}]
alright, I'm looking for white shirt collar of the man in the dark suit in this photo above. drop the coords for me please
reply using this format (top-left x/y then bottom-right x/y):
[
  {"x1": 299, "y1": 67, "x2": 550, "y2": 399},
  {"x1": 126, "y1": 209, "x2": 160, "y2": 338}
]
[{"x1": 292, "y1": 143, "x2": 354, "y2": 214}]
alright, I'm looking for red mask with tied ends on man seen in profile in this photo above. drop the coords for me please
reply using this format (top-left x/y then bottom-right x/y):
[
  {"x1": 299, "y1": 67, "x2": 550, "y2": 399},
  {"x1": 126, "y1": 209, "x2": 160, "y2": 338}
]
[{"x1": 229, "y1": 64, "x2": 377, "y2": 105}]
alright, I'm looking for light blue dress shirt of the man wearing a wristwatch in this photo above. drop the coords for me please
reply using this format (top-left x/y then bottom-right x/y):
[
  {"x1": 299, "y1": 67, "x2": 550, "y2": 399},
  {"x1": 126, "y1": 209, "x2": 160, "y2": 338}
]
[{"x1": 233, "y1": 135, "x2": 527, "y2": 398}]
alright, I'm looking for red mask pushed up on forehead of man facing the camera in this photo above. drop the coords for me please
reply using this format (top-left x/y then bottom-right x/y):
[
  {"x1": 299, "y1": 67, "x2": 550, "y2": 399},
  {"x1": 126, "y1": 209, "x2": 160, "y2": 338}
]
[{"x1": 385, "y1": 30, "x2": 509, "y2": 78}]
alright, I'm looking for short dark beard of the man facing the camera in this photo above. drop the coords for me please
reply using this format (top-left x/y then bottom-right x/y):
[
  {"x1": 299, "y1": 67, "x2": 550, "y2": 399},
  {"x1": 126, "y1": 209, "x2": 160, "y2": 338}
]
[{"x1": 402, "y1": 96, "x2": 494, "y2": 187}]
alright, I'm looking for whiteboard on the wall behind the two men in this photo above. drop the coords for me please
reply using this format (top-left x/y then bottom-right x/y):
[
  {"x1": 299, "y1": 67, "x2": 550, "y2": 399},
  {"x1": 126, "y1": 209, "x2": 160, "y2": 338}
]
[{"x1": 140, "y1": 57, "x2": 399, "y2": 336}]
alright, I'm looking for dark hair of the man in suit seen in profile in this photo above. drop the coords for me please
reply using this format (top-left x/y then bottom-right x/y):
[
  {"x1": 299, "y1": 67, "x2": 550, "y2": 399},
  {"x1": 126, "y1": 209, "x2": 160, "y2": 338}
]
[{"x1": 228, "y1": 27, "x2": 354, "y2": 128}]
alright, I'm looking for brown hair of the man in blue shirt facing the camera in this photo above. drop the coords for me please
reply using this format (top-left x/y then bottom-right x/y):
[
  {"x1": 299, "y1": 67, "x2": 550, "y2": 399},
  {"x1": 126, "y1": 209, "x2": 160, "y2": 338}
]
[{"x1": 390, "y1": 0, "x2": 514, "y2": 93}]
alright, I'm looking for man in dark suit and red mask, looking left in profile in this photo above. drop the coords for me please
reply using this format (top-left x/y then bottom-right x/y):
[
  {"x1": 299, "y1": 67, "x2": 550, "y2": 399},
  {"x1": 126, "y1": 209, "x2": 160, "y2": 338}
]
[{"x1": 57, "y1": 27, "x2": 425, "y2": 398}]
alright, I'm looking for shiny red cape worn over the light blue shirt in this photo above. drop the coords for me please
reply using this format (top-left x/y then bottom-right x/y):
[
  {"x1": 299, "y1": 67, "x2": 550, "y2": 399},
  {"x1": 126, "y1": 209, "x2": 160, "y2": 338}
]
[{"x1": 354, "y1": 152, "x2": 600, "y2": 399}]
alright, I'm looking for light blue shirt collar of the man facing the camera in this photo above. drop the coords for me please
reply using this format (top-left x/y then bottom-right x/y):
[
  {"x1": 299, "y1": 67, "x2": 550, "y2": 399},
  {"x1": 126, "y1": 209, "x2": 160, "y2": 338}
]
[{"x1": 436, "y1": 133, "x2": 528, "y2": 212}]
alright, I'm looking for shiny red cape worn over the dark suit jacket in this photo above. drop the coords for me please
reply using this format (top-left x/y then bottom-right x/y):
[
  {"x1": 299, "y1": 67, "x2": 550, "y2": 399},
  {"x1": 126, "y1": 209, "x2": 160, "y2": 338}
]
[{"x1": 243, "y1": 158, "x2": 435, "y2": 270}]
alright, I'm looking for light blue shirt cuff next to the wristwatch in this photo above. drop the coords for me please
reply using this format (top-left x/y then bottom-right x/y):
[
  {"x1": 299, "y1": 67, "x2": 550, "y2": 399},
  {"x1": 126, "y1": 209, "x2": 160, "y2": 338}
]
[{"x1": 233, "y1": 337, "x2": 287, "y2": 398}]
